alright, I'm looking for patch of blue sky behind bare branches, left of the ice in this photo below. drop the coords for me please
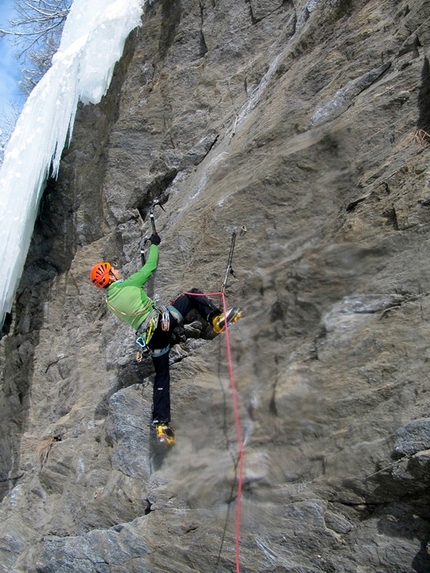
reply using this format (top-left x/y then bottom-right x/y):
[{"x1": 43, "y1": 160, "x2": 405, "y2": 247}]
[{"x1": 0, "y1": 0, "x2": 24, "y2": 123}]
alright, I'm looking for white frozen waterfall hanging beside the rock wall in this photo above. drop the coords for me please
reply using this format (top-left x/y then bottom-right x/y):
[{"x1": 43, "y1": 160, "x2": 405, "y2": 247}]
[{"x1": 0, "y1": 0, "x2": 145, "y2": 324}]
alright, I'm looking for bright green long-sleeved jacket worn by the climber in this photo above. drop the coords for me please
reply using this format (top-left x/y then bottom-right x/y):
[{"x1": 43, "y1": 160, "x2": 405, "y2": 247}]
[{"x1": 106, "y1": 245, "x2": 158, "y2": 330}]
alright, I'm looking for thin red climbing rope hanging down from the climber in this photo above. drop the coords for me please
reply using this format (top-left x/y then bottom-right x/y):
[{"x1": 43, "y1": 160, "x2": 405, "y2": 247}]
[{"x1": 182, "y1": 291, "x2": 244, "y2": 573}]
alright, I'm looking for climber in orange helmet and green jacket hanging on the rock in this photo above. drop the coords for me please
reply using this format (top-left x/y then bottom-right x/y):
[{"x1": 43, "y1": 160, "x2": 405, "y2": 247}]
[{"x1": 91, "y1": 233, "x2": 241, "y2": 444}]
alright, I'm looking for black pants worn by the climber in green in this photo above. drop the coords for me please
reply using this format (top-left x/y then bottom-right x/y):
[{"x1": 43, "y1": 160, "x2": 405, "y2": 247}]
[{"x1": 148, "y1": 289, "x2": 221, "y2": 422}]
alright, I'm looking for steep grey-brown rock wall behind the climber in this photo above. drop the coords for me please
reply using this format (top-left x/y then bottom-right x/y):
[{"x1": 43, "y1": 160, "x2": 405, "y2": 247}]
[{"x1": 0, "y1": 0, "x2": 430, "y2": 573}]
